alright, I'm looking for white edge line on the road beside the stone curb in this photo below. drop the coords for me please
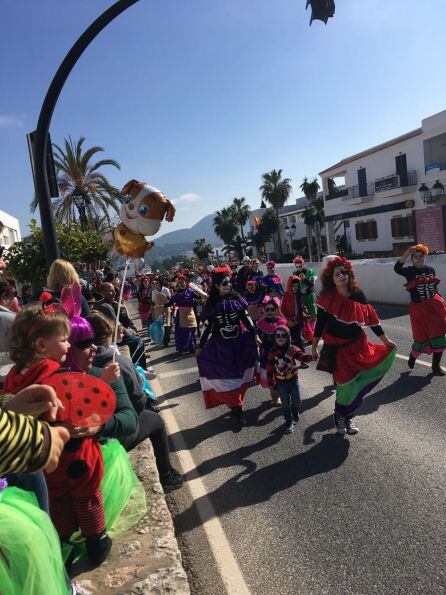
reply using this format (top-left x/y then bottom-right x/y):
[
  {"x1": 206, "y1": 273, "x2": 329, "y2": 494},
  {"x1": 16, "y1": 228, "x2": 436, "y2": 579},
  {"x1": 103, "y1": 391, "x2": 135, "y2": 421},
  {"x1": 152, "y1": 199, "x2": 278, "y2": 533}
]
[{"x1": 150, "y1": 374, "x2": 250, "y2": 595}]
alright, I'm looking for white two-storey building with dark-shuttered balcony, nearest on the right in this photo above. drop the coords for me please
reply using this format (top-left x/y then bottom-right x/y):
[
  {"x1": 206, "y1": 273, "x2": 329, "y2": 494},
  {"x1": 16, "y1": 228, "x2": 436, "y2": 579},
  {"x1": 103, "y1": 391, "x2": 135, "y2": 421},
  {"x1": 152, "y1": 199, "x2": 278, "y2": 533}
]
[{"x1": 320, "y1": 110, "x2": 446, "y2": 257}]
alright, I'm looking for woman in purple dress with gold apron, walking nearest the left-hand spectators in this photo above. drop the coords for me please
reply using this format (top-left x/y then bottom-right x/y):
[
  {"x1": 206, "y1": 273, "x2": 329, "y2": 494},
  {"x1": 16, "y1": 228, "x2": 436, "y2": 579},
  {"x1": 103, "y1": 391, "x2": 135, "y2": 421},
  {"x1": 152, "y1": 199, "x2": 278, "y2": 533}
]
[{"x1": 164, "y1": 275, "x2": 197, "y2": 353}]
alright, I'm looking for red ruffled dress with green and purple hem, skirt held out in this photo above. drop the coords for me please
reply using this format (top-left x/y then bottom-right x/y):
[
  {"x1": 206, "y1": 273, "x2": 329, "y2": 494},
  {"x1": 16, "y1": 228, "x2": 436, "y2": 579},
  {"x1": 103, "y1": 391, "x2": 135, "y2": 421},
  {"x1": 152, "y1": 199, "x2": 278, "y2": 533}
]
[{"x1": 315, "y1": 290, "x2": 396, "y2": 417}]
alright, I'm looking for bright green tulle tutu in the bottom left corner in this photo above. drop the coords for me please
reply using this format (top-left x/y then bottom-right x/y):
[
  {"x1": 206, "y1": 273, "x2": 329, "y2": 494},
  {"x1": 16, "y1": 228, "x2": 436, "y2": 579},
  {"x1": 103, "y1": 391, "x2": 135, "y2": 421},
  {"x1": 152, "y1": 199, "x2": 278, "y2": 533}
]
[{"x1": 0, "y1": 488, "x2": 70, "y2": 595}]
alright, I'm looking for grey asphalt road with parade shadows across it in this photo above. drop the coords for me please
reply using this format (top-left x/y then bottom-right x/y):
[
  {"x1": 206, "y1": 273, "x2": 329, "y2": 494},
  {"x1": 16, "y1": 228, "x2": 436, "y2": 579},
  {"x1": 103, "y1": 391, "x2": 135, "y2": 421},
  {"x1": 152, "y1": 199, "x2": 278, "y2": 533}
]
[{"x1": 146, "y1": 307, "x2": 446, "y2": 595}]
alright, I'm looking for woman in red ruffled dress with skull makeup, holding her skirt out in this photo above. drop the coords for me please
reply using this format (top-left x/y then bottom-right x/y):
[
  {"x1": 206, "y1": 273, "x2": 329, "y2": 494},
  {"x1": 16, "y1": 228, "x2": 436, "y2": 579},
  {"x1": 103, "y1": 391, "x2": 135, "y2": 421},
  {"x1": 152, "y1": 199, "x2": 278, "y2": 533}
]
[{"x1": 313, "y1": 257, "x2": 396, "y2": 434}]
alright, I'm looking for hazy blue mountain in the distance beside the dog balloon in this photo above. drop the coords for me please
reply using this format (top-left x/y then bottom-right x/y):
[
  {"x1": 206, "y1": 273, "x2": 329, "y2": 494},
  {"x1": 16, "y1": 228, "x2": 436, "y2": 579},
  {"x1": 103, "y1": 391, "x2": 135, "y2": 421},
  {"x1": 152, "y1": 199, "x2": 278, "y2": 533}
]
[{"x1": 145, "y1": 213, "x2": 222, "y2": 262}]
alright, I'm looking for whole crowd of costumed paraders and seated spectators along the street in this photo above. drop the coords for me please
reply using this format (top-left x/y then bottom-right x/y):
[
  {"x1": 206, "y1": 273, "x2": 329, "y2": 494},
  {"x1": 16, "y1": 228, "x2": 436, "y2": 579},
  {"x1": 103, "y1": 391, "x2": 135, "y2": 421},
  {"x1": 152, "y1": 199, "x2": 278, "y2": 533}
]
[{"x1": 0, "y1": 244, "x2": 446, "y2": 595}]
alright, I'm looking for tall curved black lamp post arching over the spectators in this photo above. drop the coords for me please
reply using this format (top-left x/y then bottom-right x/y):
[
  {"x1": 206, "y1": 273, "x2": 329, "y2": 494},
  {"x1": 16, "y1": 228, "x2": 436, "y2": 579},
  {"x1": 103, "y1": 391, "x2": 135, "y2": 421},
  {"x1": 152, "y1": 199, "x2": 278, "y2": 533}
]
[{"x1": 34, "y1": 0, "x2": 138, "y2": 265}]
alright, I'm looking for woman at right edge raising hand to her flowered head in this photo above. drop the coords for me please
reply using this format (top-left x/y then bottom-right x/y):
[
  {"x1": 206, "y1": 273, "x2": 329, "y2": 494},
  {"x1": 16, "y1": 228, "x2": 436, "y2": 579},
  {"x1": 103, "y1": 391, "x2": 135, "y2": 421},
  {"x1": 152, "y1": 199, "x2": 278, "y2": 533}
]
[{"x1": 395, "y1": 244, "x2": 446, "y2": 376}]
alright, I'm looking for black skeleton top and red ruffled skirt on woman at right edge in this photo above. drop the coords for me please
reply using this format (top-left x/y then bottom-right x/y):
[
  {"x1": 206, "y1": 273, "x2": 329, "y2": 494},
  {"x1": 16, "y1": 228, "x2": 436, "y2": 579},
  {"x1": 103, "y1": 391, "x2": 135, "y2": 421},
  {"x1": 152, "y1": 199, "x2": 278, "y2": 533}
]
[{"x1": 395, "y1": 260, "x2": 446, "y2": 358}]
